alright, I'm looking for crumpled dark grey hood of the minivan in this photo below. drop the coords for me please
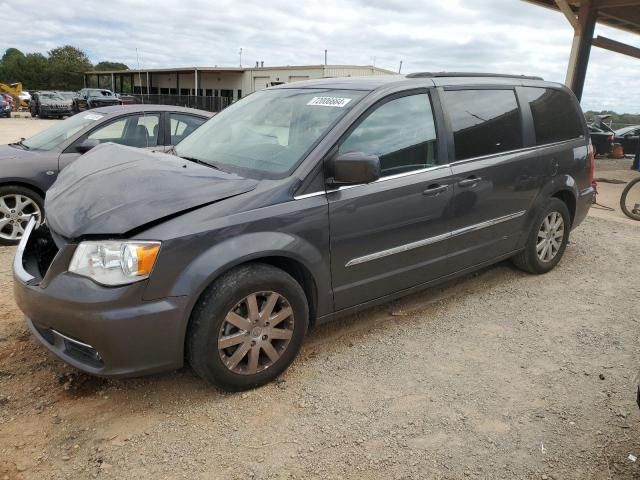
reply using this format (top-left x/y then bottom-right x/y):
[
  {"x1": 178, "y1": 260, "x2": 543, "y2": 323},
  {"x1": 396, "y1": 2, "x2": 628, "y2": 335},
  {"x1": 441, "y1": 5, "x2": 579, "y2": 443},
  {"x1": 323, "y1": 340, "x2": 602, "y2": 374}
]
[{"x1": 45, "y1": 143, "x2": 258, "y2": 238}]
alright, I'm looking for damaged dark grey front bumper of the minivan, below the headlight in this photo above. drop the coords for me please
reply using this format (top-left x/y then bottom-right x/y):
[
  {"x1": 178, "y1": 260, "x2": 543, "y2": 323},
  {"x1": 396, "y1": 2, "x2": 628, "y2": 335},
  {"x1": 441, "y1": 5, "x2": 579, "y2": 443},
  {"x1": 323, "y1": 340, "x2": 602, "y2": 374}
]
[{"x1": 13, "y1": 221, "x2": 188, "y2": 377}]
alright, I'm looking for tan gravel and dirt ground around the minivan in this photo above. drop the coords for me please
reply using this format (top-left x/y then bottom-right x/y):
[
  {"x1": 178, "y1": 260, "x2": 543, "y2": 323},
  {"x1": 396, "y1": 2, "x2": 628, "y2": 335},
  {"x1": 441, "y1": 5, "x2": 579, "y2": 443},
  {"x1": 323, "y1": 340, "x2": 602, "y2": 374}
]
[{"x1": 0, "y1": 120, "x2": 640, "y2": 480}]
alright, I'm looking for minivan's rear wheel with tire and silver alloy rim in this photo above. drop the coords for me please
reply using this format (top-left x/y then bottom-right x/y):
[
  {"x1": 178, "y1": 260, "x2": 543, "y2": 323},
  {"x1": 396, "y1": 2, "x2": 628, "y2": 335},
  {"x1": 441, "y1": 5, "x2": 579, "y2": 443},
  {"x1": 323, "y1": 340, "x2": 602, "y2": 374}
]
[{"x1": 512, "y1": 198, "x2": 571, "y2": 274}]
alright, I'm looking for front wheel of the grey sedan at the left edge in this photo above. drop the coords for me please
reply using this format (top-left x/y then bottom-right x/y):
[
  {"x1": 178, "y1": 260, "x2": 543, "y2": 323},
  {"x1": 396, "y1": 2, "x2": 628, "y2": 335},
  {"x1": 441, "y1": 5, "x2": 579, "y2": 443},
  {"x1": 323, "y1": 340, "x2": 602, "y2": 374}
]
[{"x1": 0, "y1": 185, "x2": 44, "y2": 245}]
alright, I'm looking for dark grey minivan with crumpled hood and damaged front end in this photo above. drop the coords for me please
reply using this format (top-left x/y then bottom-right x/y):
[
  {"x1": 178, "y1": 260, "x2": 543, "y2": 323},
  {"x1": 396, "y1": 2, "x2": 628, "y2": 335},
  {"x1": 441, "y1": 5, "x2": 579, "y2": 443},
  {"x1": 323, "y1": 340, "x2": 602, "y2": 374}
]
[{"x1": 14, "y1": 74, "x2": 594, "y2": 390}]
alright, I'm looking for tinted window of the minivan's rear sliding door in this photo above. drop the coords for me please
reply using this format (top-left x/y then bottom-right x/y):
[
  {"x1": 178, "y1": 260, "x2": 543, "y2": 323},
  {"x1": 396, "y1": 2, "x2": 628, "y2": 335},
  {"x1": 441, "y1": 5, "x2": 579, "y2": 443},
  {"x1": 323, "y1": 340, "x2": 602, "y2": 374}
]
[{"x1": 445, "y1": 90, "x2": 522, "y2": 160}]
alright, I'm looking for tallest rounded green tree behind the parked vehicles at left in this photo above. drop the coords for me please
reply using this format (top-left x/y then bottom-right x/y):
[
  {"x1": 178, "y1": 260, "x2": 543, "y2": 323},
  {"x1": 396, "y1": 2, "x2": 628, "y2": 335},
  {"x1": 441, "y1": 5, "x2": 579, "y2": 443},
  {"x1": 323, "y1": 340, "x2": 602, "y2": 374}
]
[{"x1": 47, "y1": 45, "x2": 92, "y2": 90}]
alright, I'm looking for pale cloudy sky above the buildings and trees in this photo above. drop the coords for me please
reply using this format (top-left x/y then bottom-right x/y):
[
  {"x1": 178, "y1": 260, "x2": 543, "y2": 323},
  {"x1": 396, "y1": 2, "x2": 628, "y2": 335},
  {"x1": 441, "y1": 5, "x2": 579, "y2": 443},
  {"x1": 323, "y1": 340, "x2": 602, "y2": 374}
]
[{"x1": 0, "y1": 0, "x2": 640, "y2": 113}]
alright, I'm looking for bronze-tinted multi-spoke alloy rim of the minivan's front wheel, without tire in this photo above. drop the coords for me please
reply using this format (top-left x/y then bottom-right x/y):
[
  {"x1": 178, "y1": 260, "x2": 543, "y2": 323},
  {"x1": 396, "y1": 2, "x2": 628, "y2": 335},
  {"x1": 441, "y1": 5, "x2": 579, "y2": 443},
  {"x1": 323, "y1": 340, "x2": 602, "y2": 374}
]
[{"x1": 218, "y1": 292, "x2": 294, "y2": 375}]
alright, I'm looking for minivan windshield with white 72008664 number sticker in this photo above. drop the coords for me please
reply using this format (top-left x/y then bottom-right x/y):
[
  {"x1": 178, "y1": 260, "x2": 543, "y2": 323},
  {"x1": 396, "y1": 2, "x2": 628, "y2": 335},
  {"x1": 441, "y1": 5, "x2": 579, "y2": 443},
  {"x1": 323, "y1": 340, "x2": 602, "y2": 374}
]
[{"x1": 175, "y1": 89, "x2": 366, "y2": 178}]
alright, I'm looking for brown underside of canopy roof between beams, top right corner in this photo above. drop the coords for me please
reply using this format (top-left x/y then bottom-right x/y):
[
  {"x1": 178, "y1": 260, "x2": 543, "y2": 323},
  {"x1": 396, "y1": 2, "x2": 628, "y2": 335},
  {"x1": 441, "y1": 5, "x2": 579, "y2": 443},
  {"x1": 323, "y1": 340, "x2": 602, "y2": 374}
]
[{"x1": 527, "y1": 0, "x2": 640, "y2": 34}]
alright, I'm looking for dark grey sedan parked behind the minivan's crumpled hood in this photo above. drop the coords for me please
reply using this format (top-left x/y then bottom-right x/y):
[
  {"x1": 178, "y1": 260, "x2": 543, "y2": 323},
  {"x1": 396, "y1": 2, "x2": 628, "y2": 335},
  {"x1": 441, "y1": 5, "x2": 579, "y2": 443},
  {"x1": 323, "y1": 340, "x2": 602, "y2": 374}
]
[{"x1": 0, "y1": 105, "x2": 212, "y2": 245}]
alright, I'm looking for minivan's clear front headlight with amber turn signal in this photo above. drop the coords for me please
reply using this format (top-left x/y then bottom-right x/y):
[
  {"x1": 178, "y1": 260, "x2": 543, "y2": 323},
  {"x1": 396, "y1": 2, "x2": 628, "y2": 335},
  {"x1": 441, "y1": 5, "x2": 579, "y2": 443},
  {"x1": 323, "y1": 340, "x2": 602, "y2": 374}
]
[{"x1": 69, "y1": 240, "x2": 160, "y2": 286}]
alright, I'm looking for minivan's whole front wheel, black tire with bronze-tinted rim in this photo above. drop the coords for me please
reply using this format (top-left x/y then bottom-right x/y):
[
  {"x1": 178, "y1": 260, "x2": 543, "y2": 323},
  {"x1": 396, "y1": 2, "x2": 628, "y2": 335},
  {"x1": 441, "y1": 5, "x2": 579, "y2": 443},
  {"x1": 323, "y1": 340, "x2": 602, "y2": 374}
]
[{"x1": 186, "y1": 263, "x2": 309, "y2": 391}]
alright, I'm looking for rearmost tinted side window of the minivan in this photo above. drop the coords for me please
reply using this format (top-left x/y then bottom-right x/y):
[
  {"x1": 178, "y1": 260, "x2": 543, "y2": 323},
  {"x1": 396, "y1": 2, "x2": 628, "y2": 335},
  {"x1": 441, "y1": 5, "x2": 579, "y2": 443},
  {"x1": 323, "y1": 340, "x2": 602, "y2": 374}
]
[{"x1": 523, "y1": 87, "x2": 584, "y2": 145}]
